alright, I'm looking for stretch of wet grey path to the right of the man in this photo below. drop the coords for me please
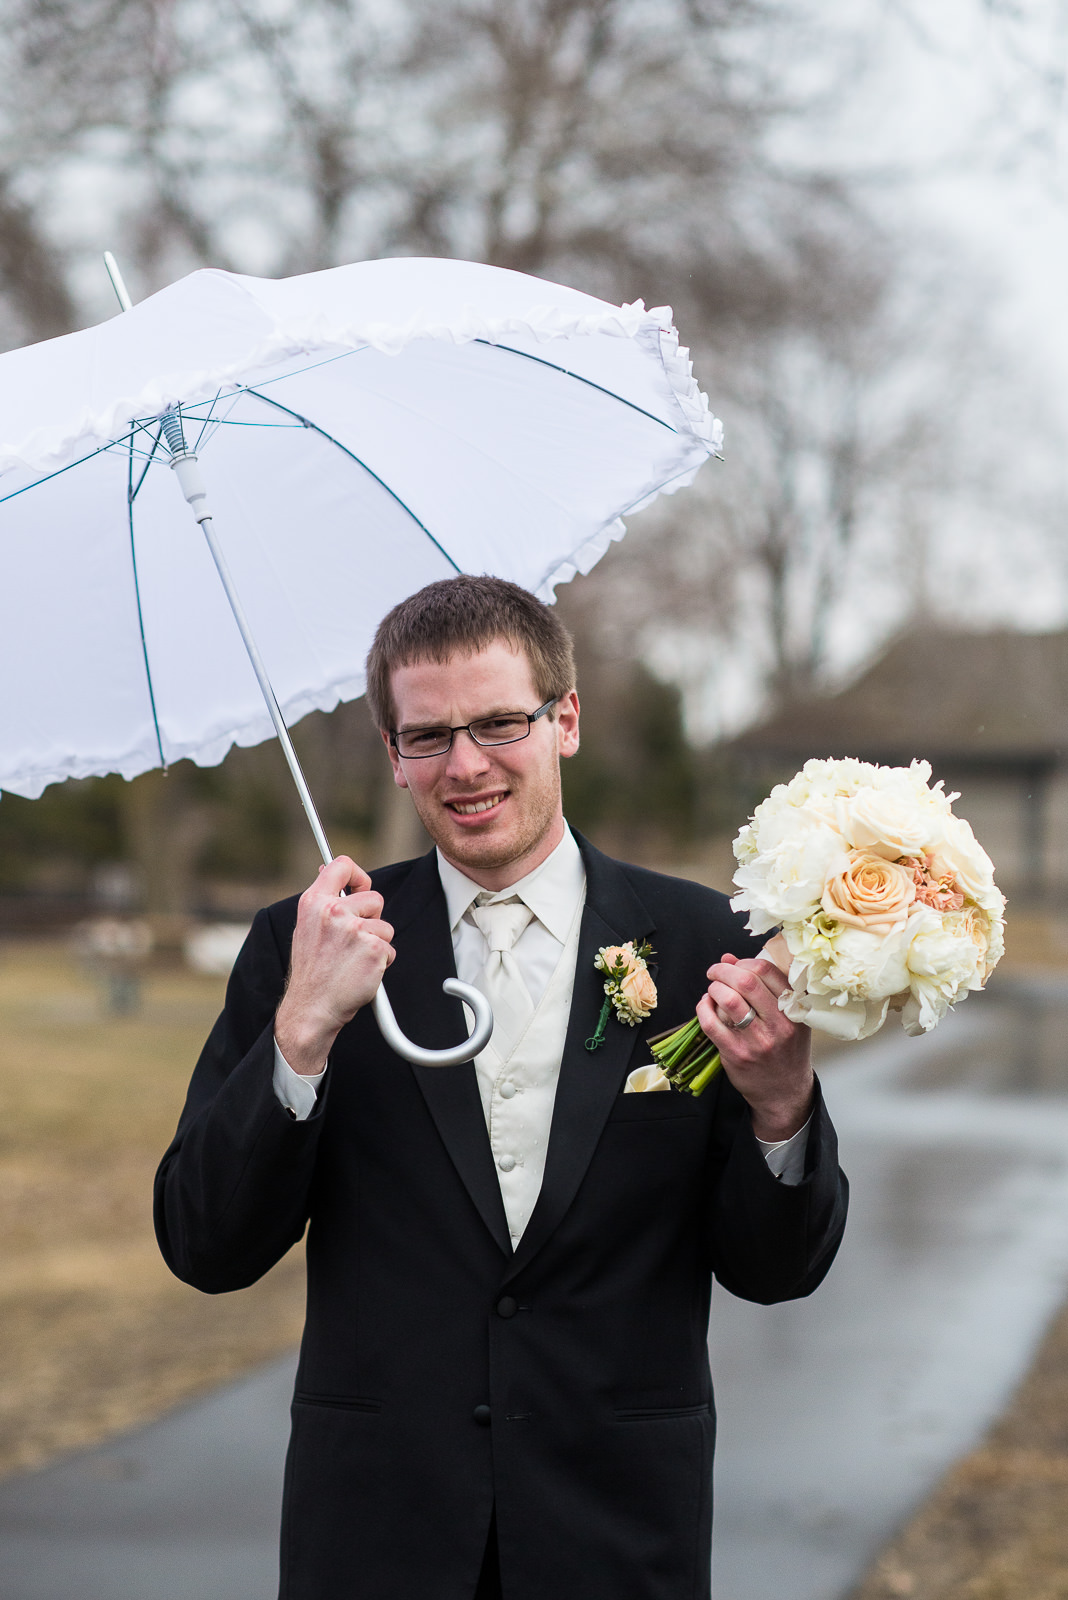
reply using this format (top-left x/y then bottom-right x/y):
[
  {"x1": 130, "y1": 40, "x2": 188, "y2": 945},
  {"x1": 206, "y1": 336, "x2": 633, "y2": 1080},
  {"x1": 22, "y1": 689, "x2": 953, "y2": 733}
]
[{"x1": 711, "y1": 982, "x2": 1068, "y2": 1600}]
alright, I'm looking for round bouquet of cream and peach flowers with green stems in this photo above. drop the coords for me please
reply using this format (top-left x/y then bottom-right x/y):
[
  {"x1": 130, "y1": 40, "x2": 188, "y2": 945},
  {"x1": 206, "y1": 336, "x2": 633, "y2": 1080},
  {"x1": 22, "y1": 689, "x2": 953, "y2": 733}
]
[{"x1": 652, "y1": 760, "x2": 1006, "y2": 1094}]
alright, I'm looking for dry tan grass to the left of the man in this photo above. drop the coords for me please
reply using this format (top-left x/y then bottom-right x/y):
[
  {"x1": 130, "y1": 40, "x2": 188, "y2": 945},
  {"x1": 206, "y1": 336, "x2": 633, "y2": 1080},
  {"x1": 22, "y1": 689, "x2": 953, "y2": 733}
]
[{"x1": 0, "y1": 942, "x2": 304, "y2": 1472}]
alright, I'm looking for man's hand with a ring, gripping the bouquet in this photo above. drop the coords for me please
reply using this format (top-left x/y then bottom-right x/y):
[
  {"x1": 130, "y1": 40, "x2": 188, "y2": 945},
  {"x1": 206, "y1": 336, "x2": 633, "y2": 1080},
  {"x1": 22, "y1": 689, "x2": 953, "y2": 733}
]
[{"x1": 697, "y1": 955, "x2": 815, "y2": 1144}]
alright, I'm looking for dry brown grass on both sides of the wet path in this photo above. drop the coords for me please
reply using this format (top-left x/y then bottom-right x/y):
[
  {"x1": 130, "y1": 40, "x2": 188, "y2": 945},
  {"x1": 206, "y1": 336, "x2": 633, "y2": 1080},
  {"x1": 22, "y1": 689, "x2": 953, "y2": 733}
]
[{"x1": 0, "y1": 902, "x2": 1068, "y2": 1600}]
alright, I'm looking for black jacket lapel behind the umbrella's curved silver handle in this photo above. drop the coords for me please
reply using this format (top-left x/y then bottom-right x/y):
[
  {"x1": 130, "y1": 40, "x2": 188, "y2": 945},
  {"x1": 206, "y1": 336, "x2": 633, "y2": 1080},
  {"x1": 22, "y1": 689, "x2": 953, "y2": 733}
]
[{"x1": 382, "y1": 851, "x2": 512, "y2": 1256}]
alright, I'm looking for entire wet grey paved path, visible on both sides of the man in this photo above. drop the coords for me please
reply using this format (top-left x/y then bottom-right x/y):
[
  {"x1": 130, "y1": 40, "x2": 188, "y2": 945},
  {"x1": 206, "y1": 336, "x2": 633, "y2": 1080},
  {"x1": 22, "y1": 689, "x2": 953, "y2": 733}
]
[{"x1": 0, "y1": 982, "x2": 1068, "y2": 1600}]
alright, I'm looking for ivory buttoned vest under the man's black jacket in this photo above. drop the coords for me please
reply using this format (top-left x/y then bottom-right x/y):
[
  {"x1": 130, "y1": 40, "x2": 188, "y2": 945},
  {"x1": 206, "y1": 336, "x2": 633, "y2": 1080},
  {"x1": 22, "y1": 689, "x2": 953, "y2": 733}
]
[{"x1": 475, "y1": 896, "x2": 585, "y2": 1250}]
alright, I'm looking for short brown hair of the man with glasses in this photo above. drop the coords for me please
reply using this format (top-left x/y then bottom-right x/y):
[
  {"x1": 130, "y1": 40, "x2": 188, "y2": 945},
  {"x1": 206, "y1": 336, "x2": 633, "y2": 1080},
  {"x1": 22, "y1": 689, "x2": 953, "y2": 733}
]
[{"x1": 368, "y1": 573, "x2": 576, "y2": 733}]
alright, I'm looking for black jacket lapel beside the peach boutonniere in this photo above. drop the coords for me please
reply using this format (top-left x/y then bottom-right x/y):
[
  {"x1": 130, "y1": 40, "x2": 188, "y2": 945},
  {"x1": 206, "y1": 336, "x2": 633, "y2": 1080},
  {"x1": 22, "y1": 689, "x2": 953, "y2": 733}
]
[{"x1": 508, "y1": 834, "x2": 656, "y2": 1277}]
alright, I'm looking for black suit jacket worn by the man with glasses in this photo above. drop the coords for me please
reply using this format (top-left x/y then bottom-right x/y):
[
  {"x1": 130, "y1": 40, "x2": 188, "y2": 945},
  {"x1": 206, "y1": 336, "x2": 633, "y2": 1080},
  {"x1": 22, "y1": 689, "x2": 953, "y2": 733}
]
[{"x1": 155, "y1": 842, "x2": 846, "y2": 1600}]
